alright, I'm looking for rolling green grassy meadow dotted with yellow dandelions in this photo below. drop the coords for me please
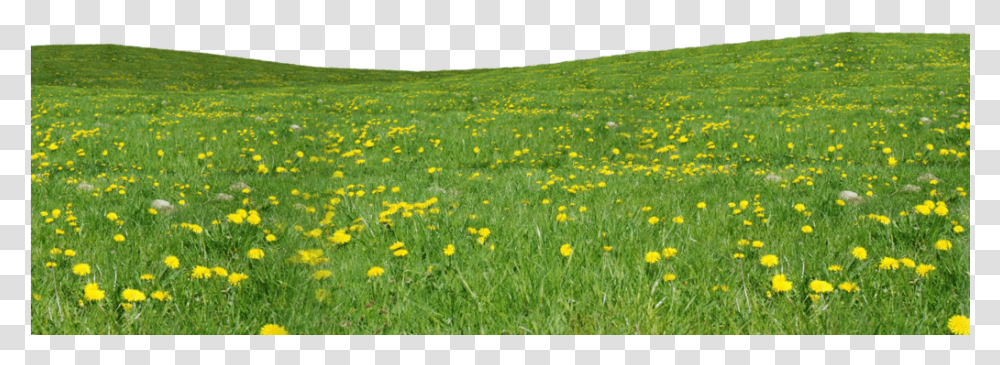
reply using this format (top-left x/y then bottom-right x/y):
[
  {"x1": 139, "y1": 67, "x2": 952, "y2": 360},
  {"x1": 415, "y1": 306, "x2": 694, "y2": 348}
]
[{"x1": 31, "y1": 33, "x2": 970, "y2": 334}]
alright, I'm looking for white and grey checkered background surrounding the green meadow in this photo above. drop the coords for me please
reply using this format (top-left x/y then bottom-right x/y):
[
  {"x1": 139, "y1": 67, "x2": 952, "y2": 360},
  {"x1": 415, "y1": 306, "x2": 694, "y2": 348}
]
[{"x1": 0, "y1": 0, "x2": 1000, "y2": 364}]
